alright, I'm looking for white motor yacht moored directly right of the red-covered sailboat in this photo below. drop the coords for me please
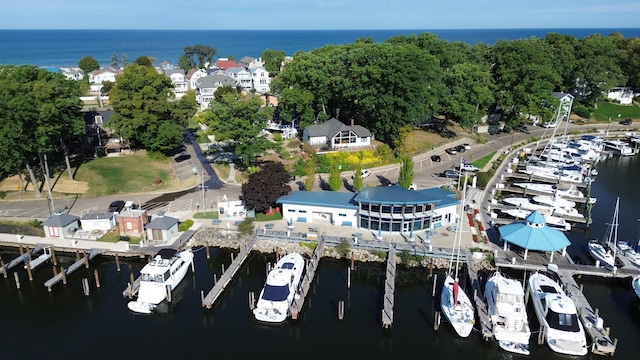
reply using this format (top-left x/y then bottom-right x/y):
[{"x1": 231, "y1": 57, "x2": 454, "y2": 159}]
[{"x1": 485, "y1": 272, "x2": 531, "y2": 355}]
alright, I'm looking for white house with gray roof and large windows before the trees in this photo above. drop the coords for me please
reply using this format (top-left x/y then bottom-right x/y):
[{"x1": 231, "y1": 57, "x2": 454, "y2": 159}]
[{"x1": 302, "y1": 118, "x2": 372, "y2": 149}]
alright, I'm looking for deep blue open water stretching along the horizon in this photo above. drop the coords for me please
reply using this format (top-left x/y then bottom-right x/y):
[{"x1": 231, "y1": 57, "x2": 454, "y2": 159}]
[{"x1": 0, "y1": 28, "x2": 640, "y2": 67}]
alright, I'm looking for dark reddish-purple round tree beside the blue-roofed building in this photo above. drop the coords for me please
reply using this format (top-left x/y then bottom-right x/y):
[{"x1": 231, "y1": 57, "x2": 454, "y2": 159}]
[{"x1": 242, "y1": 162, "x2": 291, "y2": 213}]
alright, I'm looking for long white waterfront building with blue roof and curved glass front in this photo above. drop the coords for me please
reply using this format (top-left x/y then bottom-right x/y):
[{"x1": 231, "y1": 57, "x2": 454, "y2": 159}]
[{"x1": 278, "y1": 186, "x2": 460, "y2": 233}]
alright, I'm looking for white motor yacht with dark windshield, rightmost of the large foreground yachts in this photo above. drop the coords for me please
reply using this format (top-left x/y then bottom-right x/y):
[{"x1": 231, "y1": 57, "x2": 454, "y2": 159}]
[{"x1": 529, "y1": 273, "x2": 587, "y2": 355}]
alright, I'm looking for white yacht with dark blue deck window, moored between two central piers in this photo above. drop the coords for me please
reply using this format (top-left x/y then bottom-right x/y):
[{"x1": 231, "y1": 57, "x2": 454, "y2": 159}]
[{"x1": 253, "y1": 253, "x2": 305, "y2": 323}]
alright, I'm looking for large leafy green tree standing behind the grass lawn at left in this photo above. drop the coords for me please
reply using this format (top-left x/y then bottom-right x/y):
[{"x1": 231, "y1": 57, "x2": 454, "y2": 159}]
[{"x1": 109, "y1": 63, "x2": 184, "y2": 152}]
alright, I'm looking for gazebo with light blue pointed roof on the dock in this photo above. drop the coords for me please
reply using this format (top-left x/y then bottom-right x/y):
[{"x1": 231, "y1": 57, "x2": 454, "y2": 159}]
[{"x1": 498, "y1": 210, "x2": 571, "y2": 262}]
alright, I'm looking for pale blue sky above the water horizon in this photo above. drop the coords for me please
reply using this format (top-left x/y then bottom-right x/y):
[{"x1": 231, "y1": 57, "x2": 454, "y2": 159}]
[{"x1": 0, "y1": 0, "x2": 640, "y2": 30}]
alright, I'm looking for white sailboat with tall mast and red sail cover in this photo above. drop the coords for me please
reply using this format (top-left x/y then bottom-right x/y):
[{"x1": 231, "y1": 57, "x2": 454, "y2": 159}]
[{"x1": 440, "y1": 182, "x2": 475, "y2": 337}]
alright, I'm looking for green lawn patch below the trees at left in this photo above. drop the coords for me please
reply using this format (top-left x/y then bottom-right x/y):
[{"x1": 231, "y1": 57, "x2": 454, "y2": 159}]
[{"x1": 75, "y1": 154, "x2": 173, "y2": 197}]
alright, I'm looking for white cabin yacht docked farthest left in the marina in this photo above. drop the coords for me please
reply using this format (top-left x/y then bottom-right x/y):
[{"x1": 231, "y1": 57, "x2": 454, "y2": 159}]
[{"x1": 127, "y1": 248, "x2": 193, "y2": 314}]
